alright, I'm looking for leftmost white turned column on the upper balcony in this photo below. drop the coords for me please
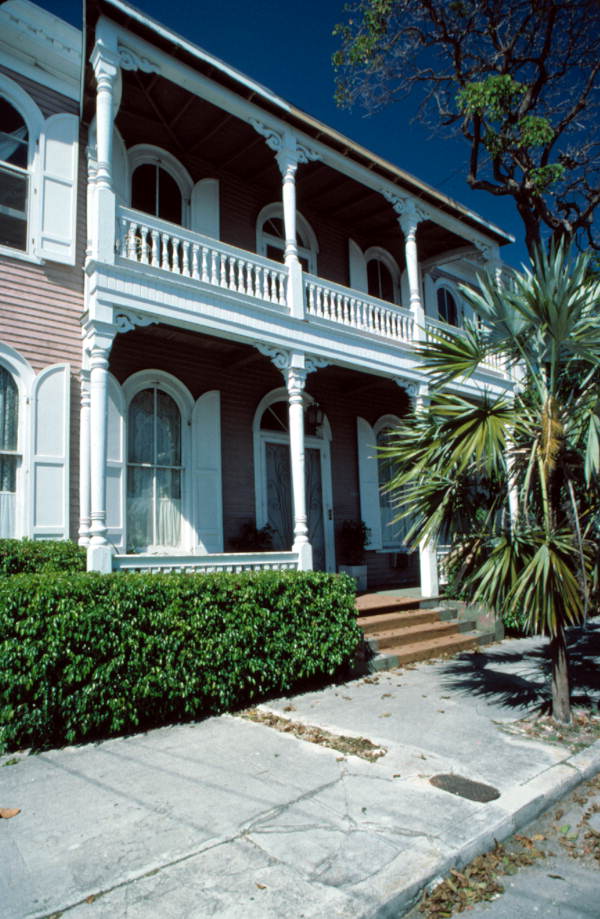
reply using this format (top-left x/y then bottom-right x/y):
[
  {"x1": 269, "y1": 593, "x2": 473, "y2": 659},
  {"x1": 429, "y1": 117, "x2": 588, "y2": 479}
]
[{"x1": 90, "y1": 38, "x2": 121, "y2": 263}]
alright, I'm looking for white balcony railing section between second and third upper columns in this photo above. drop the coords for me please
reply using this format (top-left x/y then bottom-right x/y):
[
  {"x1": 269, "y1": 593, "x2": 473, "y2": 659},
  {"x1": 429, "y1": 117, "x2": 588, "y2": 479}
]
[{"x1": 304, "y1": 275, "x2": 414, "y2": 344}]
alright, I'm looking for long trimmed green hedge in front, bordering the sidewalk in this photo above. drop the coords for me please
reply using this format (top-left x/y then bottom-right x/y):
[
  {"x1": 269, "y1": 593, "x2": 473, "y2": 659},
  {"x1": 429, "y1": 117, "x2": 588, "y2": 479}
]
[{"x1": 0, "y1": 572, "x2": 361, "y2": 752}]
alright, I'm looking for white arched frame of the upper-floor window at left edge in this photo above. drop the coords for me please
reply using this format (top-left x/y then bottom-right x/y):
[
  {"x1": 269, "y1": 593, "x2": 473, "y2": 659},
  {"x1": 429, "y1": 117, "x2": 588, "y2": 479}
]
[{"x1": 0, "y1": 74, "x2": 44, "y2": 264}]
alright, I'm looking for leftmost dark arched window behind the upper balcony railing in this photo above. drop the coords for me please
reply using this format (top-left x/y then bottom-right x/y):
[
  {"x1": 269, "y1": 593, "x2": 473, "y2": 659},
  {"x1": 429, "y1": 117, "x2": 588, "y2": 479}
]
[{"x1": 128, "y1": 144, "x2": 192, "y2": 226}]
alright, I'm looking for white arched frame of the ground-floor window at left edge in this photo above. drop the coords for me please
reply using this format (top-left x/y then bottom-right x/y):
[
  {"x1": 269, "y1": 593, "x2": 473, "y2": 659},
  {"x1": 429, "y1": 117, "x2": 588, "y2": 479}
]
[{"x1": 0, "y1": 342, "x2": 35, "y2": 539}]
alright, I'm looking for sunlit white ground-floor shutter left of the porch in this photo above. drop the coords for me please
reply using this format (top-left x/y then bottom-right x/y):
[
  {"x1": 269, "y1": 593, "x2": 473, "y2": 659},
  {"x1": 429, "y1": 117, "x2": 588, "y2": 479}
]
[{"x1": 31, "y1": 364, "x2": 71, "y2": 539}]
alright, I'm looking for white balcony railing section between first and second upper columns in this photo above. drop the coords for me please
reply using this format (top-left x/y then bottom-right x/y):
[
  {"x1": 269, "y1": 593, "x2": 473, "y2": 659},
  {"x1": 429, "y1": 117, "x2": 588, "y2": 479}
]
[{"x1": 117, "y1": 207, "x2": 287, "y2": 306}]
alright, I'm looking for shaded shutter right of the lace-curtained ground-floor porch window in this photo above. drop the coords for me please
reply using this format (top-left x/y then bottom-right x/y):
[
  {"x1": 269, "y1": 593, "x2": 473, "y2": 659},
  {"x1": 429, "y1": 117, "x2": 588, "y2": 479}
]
[{"x1": 192, "y1": 389, "x2": 223, "y2": 553}]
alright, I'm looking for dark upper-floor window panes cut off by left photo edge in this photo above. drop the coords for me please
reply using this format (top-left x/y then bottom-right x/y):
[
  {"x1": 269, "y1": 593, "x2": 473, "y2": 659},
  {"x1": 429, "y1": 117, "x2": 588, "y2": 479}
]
[{"x1": 0, "y1": 96, "x2": 29, "y2": 251}]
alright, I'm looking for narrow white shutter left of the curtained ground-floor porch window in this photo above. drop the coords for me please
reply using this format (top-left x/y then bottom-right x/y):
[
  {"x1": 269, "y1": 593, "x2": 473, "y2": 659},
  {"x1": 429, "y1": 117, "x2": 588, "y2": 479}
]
[{"x1": 106, "y1": 374, "x2": 126, "y2": 552}]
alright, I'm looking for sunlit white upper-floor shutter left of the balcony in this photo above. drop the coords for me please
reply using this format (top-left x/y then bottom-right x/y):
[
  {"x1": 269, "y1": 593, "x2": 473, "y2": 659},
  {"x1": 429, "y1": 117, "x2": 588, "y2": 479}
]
[{"x1": 36, "y1": 114, "x2": 79, "y2": 265}]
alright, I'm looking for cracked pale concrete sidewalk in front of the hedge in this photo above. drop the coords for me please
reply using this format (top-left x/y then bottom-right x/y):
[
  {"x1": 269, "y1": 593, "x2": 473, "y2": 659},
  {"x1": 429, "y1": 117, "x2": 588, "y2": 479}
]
[{"x1": 0, "y1": 622, "x2": 600, "y2": 919}]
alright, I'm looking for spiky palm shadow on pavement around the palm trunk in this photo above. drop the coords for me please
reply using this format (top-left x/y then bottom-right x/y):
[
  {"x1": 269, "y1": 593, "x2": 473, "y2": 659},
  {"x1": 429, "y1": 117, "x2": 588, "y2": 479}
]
[{"x1": 442, "y1": 620, "x2": 600, "y2": 710}]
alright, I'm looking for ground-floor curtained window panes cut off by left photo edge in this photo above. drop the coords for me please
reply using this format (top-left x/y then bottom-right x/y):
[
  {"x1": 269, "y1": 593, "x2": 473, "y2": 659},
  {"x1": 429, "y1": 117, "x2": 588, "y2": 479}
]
[{"x1": 0, "y1": 367, "x2": 19, "y2": 538}]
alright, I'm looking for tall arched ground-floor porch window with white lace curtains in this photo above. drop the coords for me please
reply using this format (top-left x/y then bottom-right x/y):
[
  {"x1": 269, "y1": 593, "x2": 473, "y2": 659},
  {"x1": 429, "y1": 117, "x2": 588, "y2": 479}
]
[{"x1": 127, "y1": 386, "x2": 183, "y2": 551}]
